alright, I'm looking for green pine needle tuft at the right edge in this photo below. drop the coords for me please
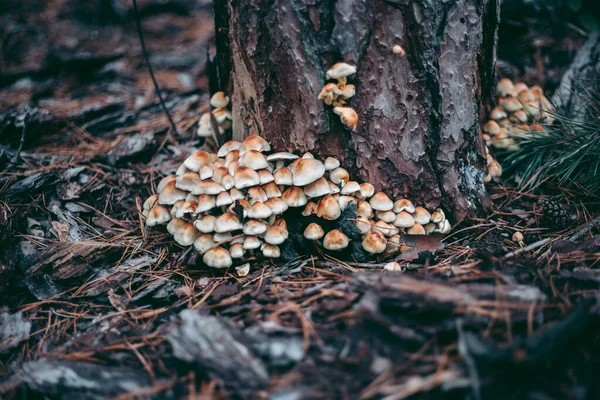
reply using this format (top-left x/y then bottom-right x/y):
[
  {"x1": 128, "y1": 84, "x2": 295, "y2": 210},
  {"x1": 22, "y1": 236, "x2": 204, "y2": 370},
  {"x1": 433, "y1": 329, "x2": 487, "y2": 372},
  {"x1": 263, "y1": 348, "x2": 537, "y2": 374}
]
[{"x1": 501, "y1": 80, "x2": 600, "y2": 195}]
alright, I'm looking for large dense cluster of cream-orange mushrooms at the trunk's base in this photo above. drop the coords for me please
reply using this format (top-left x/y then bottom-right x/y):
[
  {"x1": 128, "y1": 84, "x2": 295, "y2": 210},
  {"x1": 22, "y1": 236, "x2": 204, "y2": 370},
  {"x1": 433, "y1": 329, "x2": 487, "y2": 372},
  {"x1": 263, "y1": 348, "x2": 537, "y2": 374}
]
[{"x1": 143, "y1": 135, "x2": 451, "y2": 270}]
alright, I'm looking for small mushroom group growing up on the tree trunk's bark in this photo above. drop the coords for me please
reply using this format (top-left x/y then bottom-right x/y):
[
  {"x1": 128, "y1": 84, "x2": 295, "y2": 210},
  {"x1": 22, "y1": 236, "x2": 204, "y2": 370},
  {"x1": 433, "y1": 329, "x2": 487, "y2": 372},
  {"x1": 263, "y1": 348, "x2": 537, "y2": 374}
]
[{"x1": 318, "y1": 62, "x2": 358, "y2": 131}]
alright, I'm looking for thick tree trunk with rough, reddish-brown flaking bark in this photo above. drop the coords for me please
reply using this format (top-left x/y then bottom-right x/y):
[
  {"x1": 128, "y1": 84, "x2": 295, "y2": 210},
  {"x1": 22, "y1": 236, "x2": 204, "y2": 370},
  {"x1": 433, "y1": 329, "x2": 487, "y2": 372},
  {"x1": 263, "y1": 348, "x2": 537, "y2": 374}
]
[{"x1": 215, "y1": 0, "x2": 499, "y2": 220}]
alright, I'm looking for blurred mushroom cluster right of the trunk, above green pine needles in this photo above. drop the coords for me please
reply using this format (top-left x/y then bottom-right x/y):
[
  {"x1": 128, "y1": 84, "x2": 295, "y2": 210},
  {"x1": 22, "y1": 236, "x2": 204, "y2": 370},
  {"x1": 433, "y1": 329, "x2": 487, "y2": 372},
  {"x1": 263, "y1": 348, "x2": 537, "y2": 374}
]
[{"x1": 483, "y1": 78, "x2": 553, "y2": 152}]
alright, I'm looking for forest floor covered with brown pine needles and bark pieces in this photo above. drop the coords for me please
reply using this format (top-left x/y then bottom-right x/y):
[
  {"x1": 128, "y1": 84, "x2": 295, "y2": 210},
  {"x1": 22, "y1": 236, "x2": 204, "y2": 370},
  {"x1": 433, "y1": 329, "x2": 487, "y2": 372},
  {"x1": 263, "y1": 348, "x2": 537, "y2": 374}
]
[{"x1": 0, "y1": 0, "x2": 600, "y2": 400}]
